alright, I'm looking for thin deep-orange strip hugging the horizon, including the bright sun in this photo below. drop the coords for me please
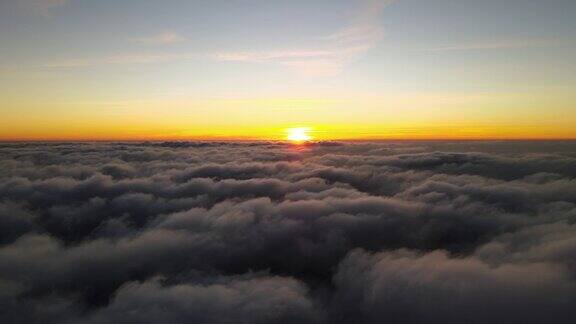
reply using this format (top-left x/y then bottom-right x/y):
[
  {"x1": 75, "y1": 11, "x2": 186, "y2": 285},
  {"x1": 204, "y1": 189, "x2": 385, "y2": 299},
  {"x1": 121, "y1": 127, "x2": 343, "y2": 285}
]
[{"x1": 0, "y1": 125, "x2": 576, "y2": 144}]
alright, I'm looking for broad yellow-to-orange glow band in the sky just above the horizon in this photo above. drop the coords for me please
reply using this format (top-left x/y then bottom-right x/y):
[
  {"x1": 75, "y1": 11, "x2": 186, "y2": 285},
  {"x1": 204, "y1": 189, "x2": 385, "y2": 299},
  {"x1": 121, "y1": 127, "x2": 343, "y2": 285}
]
[{"x1": 0, "y1": 93, "x2": 576, "y2": 142}]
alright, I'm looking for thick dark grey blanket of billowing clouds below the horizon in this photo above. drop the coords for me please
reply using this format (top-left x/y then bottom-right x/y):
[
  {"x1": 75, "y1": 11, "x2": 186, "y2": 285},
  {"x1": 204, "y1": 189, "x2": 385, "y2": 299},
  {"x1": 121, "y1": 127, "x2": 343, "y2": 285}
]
[{"x1": 0, "y1": 142, "x2": 576, "y2": 323}]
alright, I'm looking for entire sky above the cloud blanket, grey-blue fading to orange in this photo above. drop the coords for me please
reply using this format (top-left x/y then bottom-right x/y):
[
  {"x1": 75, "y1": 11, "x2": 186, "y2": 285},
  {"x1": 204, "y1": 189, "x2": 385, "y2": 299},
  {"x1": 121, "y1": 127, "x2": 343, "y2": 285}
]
[{"x1": 0, "y1": 0, "x2": 576, "y2": 140}]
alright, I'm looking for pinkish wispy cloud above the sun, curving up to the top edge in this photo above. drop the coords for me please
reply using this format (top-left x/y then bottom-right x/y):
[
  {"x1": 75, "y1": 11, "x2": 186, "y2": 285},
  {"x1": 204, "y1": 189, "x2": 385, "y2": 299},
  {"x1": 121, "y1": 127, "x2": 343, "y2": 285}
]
[{"x1": 213, "y1": 0, "x2": 392, "y2": 76}]
